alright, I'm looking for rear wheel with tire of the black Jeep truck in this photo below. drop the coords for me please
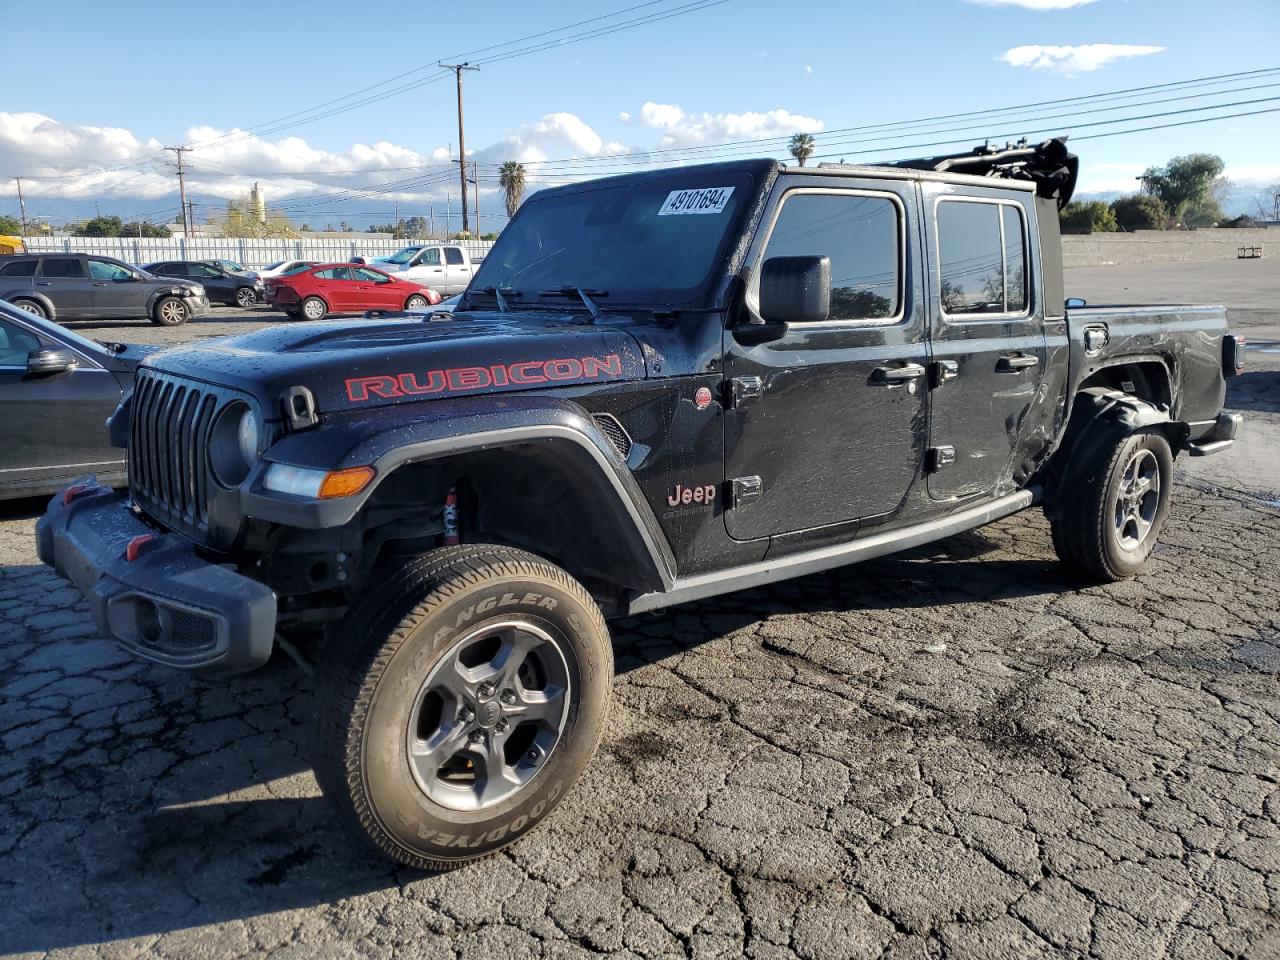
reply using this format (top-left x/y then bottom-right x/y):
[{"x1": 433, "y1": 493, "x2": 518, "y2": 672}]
[{"x1": 1052, "y1": 430, "x2": 1174, "y2": 581}]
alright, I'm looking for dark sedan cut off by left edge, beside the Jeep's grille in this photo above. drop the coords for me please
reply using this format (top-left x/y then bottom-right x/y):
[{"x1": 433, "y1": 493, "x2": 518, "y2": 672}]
[{"x1": 0, "y1": 300, "x2": 152, "y2": 499}]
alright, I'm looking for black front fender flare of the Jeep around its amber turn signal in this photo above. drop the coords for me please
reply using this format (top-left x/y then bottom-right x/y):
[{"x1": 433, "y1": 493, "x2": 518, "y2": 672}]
[{"x1": 239, "y1": 396, "x2": 676, "y2": 590}]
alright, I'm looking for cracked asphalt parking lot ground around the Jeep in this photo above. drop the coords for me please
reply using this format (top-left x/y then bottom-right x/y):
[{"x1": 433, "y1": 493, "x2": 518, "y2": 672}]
[{"x1": 0, "y1": 260, "x2": 1280, "y2": 960}]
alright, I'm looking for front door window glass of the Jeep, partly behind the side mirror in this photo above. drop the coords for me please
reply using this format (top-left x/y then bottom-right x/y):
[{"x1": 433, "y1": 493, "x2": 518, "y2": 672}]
[{"x1": 764, "y1": 193, "x2": 902, "y2": 320}]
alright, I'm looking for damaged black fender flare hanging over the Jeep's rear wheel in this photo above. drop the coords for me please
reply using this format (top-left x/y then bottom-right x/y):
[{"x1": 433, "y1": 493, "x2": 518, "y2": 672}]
[{"x1": 1044, "y1": 389, "x2": 1188, "y2": 517}]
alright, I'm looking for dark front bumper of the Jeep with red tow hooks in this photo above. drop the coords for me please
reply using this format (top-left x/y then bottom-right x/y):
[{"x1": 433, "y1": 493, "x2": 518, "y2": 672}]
[{"x1": 36, "y1": 477, "x2": 275, "y2": 673}]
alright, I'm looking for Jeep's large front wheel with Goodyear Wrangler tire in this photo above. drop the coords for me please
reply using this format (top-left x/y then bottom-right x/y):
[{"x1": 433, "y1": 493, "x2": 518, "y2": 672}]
[{"x1": 314, "y1": 544, "x2": 613, "y2": 870}]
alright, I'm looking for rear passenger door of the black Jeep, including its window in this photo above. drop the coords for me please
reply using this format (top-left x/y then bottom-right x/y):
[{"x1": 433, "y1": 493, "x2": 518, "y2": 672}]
[{"x1": 924, "y1": 189, "x2": 1047, "y2": 500}]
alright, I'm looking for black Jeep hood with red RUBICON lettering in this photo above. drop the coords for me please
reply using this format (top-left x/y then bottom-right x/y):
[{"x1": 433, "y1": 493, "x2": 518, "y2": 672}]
[{"x1": 142, "y1": 311, "x2": 645, "y2": 419}]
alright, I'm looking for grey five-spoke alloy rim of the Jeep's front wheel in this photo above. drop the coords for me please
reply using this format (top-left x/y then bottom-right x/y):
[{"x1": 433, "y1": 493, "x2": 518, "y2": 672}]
[{"x1": 406, "y1": 620, "x2": 571, "y2": 810}]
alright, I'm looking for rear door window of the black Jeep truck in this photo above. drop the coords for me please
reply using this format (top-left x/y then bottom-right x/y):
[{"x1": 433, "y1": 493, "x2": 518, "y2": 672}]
[{"x1": 938, "y1": 200, "x2": 1028, "y2": 316}]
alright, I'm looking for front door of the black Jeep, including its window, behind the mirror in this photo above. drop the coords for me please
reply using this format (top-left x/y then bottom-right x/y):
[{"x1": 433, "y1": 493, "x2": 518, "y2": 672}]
[{"x1": 724, "y1": 177, "x2": 929, "y2": 540}]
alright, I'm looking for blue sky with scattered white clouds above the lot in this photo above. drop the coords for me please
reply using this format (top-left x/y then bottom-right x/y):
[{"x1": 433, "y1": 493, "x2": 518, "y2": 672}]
[{"x1": 0, "y1": 0, "x2": 1280, "y2": 227}]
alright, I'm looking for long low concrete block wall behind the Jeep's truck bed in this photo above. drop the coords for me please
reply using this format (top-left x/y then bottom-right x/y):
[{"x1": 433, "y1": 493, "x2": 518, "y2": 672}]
[{"x1": 1062, "y1": 229, "x2": 1280, "y2": 266}]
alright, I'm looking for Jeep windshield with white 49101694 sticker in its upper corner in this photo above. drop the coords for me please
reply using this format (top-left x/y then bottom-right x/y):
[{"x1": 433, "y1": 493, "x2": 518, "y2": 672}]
[{"x1": 472, "y1": 172, "x2": 751, "y2": 306}]
